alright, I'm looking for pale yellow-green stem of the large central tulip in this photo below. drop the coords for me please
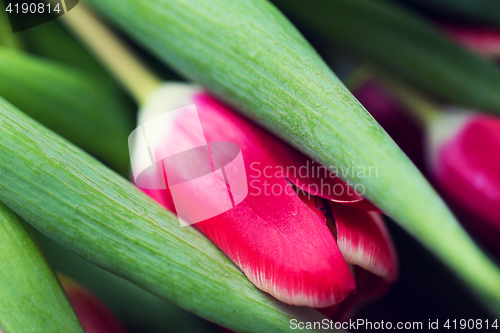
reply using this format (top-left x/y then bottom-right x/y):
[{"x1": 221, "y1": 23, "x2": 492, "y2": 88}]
[{"x1": 58, "y1": 3, "x2": 161, "y2": 105}]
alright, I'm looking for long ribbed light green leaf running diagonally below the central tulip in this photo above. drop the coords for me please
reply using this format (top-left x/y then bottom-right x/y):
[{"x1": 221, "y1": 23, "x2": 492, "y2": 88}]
[{"x1": 0, "y1": 99, "x2": 332, "y2": 332}]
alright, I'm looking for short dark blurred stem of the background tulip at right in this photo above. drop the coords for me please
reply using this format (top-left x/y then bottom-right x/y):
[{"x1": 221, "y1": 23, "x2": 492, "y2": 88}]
[{"x1": 383, "y1": 77, "x2": 442, "y2": 126}]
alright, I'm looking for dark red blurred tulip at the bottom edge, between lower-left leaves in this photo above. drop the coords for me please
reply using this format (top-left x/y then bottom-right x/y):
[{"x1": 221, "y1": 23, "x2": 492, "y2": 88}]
[{"x1": 59, "y1": 275, "x2": 127, "y2": 333}]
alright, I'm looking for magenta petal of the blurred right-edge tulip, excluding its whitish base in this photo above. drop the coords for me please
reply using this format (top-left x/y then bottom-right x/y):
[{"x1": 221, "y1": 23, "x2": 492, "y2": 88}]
[{"x1": 433, "y1": 115, "x2": 500, "y2": 243}]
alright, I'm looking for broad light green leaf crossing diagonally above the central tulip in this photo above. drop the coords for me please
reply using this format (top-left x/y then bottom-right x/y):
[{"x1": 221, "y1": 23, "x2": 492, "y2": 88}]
[{"x1": 84, "y1": 0, "x2": 500, "y2": 313}]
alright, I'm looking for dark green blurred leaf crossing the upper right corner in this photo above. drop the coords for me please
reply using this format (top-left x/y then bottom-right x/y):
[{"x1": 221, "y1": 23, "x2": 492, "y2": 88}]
[{"x1": 272, "y1": 0, "x2": 500, "y2": 113}]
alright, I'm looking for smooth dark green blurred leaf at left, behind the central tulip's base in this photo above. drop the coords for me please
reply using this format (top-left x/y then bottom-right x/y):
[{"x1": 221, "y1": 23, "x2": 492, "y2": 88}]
[{"x1": 0, "y1": 47, "x2": 133, "y2": 175}]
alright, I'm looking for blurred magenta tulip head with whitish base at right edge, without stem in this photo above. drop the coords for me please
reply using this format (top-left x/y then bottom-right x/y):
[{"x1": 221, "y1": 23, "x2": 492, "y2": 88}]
[{"x1": 430, "y1": 113, "x2": 500, "y2": 253}]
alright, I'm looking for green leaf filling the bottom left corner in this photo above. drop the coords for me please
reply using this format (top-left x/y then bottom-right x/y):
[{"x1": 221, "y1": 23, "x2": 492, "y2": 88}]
[{"x1": 0, "y1": 202, "x2": 83, "y2": 333}]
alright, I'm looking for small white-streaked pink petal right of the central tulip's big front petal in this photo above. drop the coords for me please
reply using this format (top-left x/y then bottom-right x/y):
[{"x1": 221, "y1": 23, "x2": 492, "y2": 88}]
[{"x1": 330, "y1": 203, "x2": 397, "y2": 281}]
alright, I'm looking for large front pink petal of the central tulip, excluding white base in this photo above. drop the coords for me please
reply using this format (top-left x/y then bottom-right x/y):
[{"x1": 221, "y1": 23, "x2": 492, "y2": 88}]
[{"x1": 135, "y1": 93, "x2": 355, "y2": 308}]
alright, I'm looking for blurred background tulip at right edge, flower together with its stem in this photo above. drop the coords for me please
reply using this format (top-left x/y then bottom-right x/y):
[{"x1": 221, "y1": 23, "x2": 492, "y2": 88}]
[{"x1": 376, "y1": 79, "x2": 500, "y2": 252}]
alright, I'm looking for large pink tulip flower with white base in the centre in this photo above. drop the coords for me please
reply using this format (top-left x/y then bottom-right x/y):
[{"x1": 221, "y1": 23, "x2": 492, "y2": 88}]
[{"x1": 132, "y1": 84, "x2": 397, "y2": 308}]
